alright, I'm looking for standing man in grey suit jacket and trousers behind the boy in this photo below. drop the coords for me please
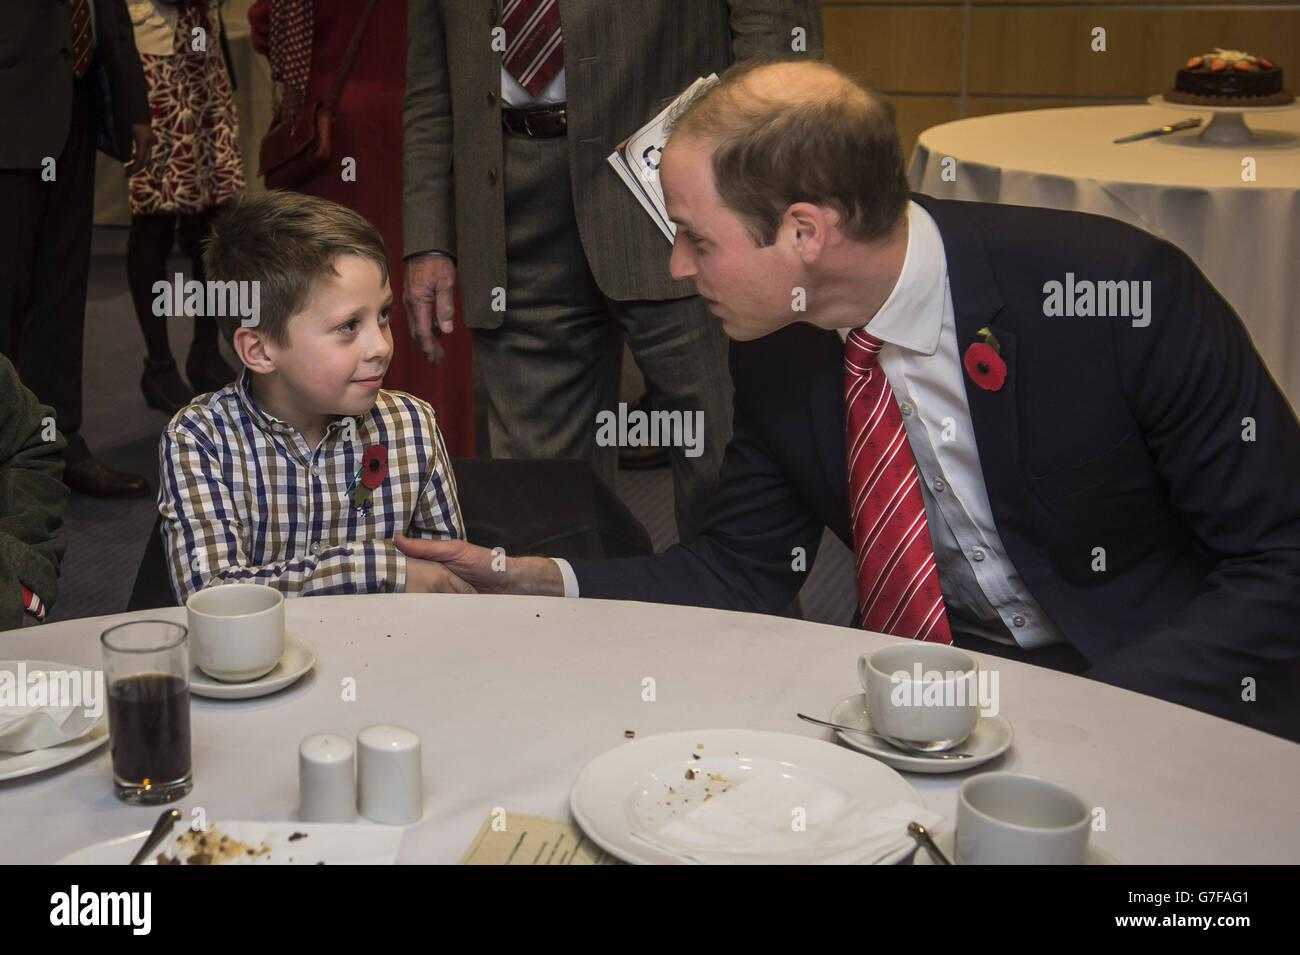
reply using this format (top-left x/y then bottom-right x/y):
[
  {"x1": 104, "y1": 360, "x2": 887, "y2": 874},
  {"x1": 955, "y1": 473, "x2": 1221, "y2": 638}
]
[{"x1": 403, "y1": 0, "x2": 822, "y2": 539}]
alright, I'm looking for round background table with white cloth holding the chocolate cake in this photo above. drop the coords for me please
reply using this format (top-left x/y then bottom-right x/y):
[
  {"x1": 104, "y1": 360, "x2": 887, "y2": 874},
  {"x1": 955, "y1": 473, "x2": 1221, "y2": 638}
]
[{"x1": 909, "y1": 105, "x2": 1300, "y2": 408}]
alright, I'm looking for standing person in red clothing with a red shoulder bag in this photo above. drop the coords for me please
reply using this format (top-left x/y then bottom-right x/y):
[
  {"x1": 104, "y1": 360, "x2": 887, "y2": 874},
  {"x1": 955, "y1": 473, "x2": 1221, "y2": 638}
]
[{"x1": 248, "y1": 0, "x2": 475, "y2": 457}]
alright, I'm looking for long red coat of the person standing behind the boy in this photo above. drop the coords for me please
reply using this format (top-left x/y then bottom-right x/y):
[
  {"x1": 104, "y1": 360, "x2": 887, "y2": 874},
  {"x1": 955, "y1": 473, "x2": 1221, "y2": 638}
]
[{"x1": 248, "y1": 0, "x2": 475, "y2": 457}]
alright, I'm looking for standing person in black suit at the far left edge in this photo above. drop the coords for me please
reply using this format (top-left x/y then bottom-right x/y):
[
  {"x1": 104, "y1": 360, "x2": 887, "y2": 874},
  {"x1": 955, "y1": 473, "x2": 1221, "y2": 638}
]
[{"x1": 0, "y1": 0, "x2": 153, "y2": 496}]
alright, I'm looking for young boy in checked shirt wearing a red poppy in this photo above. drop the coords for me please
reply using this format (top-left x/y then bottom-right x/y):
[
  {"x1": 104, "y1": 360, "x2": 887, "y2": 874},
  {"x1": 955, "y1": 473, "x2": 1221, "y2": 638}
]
[{"x1": 159, "y1": 192, "x2": 472, "y2": 603}]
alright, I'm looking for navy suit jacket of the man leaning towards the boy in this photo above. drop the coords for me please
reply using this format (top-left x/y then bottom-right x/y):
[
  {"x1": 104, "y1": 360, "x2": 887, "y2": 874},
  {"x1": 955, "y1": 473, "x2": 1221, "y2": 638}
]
[{"x1": 573, "y1": 195, "x2": 1300, "y2": 739}]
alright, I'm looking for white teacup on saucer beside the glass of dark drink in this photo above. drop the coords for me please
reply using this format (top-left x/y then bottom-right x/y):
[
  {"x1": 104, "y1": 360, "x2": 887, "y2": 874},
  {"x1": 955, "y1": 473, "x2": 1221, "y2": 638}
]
[{"x1": 185, "y1": 583, "x2": 285, "y2": 683}]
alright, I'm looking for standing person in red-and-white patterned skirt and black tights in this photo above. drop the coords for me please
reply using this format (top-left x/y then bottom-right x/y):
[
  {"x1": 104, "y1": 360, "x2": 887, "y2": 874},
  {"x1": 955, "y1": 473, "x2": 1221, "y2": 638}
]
[{"x1": 126, "y1": 0, "x2": 244, "y2": 414}]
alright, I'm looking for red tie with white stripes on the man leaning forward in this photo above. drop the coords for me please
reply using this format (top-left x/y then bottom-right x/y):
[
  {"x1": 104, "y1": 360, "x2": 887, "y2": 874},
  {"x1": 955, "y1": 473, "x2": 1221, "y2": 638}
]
[{"x1": 844, "y1": 329, "x2": 953, "y2": 643}]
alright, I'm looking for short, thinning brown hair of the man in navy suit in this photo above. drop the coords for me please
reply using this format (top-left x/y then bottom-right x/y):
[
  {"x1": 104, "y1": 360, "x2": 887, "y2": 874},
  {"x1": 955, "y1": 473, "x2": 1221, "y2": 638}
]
[{"x1": 670, "y1": 58, "x2": 910, "y2": 247}]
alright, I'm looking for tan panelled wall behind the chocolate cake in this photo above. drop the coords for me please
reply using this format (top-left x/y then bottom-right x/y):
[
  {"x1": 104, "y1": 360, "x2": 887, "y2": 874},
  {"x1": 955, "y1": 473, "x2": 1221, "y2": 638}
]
[{"x1": 822, "y1": 0, "x2": 1300, "y2": 162}]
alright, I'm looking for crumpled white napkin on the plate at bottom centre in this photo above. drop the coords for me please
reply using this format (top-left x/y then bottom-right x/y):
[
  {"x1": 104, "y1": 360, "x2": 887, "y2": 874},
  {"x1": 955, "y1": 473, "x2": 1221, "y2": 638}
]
[{"x1": 632, "y1": 773, "x2": 943, "y2": 865}]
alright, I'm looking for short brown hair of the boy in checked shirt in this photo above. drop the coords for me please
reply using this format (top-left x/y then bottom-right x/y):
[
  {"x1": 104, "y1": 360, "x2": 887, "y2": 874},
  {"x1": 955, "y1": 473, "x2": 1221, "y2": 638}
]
[{"x1": 203, "y1": 190, "x2": 389, "y2": 346}]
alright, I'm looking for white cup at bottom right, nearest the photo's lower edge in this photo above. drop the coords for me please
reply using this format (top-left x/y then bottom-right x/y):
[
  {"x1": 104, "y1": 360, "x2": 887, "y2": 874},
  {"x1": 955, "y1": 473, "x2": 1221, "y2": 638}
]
[{"x1": 957, "y1": 773, "x2": 1092, "y2": 865}]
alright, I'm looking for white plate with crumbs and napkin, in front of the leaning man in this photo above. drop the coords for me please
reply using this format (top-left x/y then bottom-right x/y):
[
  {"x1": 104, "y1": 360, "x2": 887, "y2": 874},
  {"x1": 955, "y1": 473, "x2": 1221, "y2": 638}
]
[{"x1": 569, "y1": 729, "x2": 939, "y2": 864}]
